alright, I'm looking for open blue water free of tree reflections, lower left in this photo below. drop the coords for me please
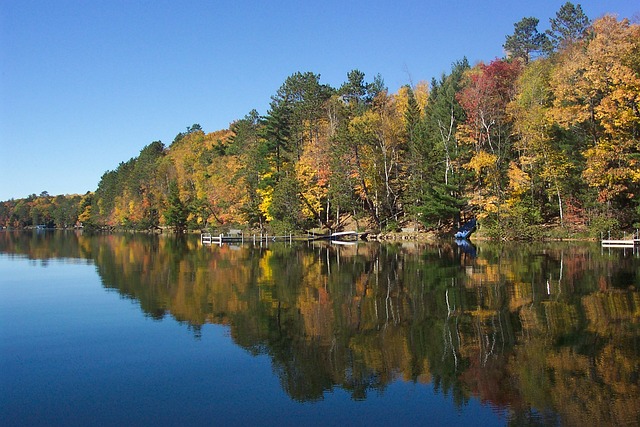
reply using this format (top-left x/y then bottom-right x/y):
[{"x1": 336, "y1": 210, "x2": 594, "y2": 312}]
[{"x1": 0, "y1": 254, "x2": 506, "y2": 426}]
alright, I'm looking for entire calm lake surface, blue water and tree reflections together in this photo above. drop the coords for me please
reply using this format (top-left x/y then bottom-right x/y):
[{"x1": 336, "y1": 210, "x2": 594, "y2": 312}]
[{"x1": 0, "y1": 232, "x2": 640, "y2": 426}]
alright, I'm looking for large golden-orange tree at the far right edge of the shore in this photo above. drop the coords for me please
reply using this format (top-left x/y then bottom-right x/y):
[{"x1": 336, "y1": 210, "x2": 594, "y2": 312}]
[{"x1": 551, "y1": 15, "x2": 640, "y2": 203}]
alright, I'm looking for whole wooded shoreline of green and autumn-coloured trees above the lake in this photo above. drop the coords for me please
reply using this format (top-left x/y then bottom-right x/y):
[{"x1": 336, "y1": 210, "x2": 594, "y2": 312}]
[{"x1": 0, "y1": 3, "x2": 640, "y2": 239}]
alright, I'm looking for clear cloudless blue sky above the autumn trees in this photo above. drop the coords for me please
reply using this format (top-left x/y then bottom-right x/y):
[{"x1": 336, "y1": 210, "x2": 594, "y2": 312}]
[{"x1": 0, "y1": 0, "x2": 640, "y2": 200}]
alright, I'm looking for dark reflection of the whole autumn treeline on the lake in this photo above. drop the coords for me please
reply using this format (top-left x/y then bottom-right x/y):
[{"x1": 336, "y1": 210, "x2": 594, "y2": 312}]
[{"x1": 0, "y1": 233, "x2": 640, "y2": 425}]
